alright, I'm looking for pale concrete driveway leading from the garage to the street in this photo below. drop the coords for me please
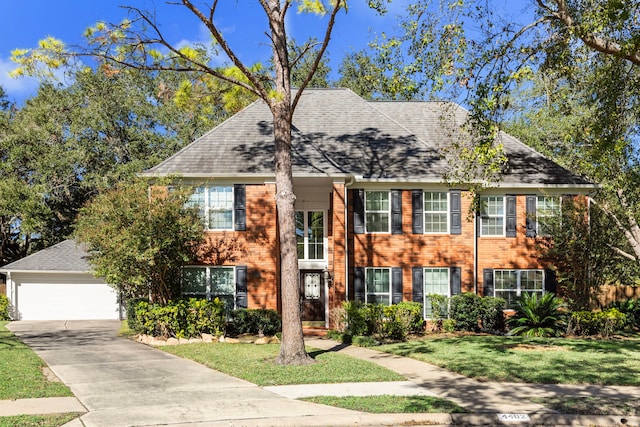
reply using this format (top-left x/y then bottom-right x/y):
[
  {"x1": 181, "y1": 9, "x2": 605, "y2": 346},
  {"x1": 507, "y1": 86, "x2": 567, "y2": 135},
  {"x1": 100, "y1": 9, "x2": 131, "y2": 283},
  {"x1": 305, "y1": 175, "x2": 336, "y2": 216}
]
[{"x1": 8, "y1": 321, "x2": 360, "y2": 426}]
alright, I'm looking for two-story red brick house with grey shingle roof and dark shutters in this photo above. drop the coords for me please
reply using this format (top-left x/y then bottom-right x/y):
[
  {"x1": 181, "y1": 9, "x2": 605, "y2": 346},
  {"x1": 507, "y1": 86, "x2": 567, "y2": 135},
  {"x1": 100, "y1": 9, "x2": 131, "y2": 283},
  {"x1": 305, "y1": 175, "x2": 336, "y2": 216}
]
[{"x1": 145, "y1": 89, "x2": 594, "y2": 326}]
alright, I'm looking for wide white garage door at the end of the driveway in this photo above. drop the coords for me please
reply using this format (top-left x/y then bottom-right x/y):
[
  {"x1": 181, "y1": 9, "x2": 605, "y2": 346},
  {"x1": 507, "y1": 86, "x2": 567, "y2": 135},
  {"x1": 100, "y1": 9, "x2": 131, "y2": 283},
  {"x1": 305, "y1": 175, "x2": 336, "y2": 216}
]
[{"x1": 17, "y1": 282, "x2": 119, "y2": 320}]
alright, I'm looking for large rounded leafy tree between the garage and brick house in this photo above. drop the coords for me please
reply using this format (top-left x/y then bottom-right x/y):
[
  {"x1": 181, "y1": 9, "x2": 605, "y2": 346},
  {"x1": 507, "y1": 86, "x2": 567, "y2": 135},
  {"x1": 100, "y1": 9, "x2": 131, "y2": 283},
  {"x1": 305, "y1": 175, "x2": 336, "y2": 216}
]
[{"x1": 76, "y1": 180, "x2": 208, "y2": 303}]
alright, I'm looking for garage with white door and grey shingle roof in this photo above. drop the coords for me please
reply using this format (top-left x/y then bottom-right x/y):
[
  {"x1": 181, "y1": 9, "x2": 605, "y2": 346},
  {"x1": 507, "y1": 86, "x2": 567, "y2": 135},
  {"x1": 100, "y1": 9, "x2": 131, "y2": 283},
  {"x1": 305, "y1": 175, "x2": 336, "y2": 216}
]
[{"x1": 0, "y1": 240, "x2": 121, "y2": 320}]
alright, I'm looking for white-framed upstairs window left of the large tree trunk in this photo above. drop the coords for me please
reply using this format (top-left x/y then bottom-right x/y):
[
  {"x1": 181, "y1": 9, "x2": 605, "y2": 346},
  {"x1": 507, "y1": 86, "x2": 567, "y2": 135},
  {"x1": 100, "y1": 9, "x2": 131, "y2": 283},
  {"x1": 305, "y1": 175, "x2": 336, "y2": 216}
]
[{"x1": 188, "y1": 185, "x2": 233, "y2": 230}]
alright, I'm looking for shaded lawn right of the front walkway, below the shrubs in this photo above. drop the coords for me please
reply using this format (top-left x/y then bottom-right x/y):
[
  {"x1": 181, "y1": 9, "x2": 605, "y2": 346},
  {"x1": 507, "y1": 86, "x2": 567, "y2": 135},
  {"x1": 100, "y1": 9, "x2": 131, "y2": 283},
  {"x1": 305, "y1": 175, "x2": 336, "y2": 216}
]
[{"x1": 375, "y1": 335, "x2": 640, "y2": 386}]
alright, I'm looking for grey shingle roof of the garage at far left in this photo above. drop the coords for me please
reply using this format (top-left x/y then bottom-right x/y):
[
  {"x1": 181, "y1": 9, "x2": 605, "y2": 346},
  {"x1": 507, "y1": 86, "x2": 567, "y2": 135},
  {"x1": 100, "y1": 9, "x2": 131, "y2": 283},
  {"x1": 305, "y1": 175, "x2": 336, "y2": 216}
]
[{"x1": 0, "y1": 240, "x2": 91, "y2": 273}]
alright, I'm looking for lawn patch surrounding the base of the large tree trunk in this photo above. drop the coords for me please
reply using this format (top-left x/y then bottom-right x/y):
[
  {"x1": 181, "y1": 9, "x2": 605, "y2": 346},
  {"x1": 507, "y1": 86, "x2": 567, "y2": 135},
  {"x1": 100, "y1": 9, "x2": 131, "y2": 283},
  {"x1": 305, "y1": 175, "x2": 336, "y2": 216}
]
[{"x1": 161, "y1": 343, "x2": 405, "y2": 386}]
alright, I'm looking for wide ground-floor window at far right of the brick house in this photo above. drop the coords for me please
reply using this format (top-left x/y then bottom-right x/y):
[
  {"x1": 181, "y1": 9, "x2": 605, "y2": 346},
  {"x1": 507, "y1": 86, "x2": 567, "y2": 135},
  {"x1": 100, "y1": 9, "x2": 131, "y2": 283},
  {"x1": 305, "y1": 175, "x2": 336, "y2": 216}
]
[{"x1": 493, "y1": 270, "x2": 544, "y2": 308}]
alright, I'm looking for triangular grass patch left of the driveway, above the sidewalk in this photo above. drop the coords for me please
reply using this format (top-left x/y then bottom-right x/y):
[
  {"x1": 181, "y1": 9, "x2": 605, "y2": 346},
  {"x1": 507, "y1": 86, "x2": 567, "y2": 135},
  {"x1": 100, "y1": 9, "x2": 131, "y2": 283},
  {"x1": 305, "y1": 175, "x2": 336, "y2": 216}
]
[{"x1": 0, "y1": 322, "x2": 73, "y2": 402}]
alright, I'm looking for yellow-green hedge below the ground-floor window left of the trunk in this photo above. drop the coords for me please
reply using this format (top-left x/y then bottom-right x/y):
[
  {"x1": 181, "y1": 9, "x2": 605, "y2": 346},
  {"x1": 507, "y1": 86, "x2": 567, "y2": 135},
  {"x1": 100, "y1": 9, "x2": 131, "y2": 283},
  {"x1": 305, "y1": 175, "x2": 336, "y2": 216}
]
[{"x1": 132, "y1": 298, "x2": 226, "y2": 338}]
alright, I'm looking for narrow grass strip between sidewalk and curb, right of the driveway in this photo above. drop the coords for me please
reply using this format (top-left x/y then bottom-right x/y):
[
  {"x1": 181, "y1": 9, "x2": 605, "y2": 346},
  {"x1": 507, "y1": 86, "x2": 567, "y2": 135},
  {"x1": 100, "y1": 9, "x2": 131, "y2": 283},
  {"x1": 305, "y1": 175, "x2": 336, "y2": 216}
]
[{"x1": 300, "y1": 396, "x2": 468, "y2": 414}]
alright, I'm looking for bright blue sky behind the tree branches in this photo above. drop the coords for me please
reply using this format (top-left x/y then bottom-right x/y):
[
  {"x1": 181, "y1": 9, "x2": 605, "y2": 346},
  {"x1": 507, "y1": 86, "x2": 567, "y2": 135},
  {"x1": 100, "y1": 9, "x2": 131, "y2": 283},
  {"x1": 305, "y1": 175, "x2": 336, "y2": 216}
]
[{"x1": 0, "y1": 0, "x2": 408, "y2": 101}]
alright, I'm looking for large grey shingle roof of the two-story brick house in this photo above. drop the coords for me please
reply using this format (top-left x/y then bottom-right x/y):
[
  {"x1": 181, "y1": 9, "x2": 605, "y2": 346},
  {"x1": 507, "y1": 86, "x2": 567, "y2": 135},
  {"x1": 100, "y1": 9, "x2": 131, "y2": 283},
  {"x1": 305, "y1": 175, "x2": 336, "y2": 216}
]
[{"x1": 146, "y1": 89, "x2": 590, "y2": 186}]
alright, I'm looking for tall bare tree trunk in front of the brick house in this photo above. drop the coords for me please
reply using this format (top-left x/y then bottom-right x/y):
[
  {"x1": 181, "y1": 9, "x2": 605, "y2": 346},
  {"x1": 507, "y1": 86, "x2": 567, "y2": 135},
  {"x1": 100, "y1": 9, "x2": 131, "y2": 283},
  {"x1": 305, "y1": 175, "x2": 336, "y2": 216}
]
[{"x1": 269, "y1": 0, "x2": 313, "y2": 365}]
